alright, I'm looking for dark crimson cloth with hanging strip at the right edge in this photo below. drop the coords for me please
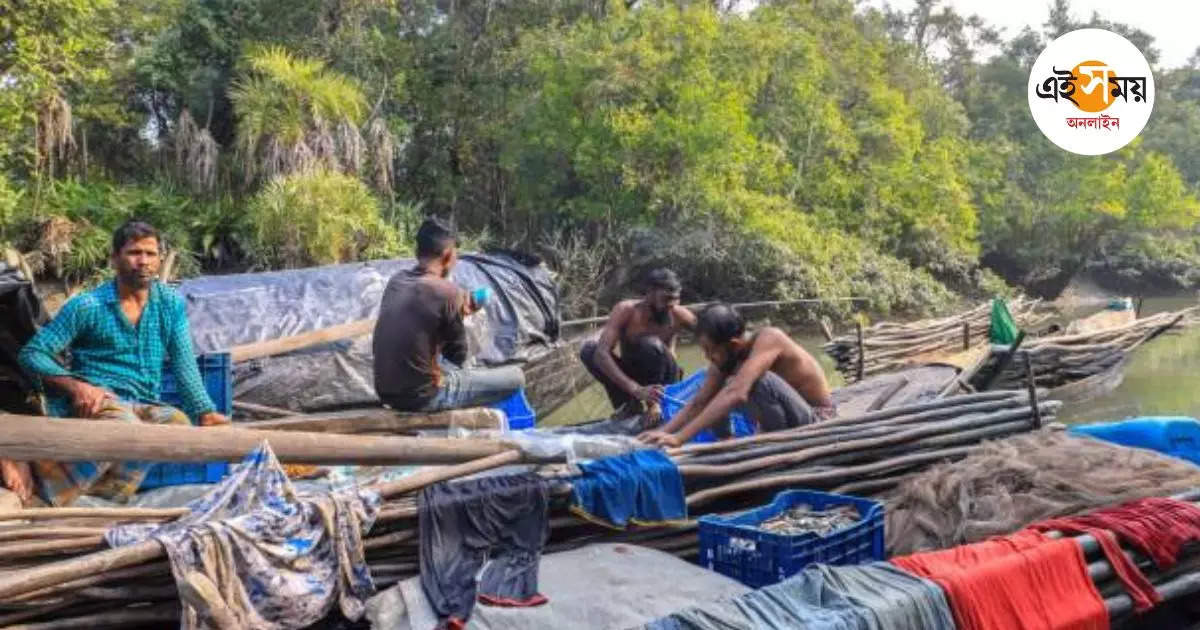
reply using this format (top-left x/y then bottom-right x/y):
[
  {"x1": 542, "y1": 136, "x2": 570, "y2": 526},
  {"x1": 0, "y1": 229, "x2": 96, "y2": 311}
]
[{"x1": 1030, "y1": 497, "x2": 1200, "y2": 611}]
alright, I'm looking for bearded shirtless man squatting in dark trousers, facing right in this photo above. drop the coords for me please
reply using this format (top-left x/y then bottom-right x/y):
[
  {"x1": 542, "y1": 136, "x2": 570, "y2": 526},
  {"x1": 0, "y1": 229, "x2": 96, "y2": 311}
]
[{"x1": 580, "y1": 269, "x2": 696, "y2": 415}]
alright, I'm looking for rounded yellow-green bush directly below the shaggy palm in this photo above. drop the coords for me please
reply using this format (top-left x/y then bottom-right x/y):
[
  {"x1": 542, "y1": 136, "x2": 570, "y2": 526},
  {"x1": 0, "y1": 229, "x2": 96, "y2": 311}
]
[{"x1": 248, "y1": 170, "x2": 408, "y2": 268}]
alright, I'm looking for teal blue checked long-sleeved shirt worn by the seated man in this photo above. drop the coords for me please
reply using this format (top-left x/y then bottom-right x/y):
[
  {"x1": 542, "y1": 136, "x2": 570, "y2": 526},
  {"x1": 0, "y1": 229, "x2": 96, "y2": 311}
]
[{"x1": 19, "y1": 281, "x2": 216, "y2": 419}]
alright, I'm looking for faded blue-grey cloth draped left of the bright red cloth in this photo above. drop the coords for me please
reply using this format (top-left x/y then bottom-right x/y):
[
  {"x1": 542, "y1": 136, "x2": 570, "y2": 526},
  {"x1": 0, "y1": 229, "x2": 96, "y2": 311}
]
[{"x1": 646, "y1": 563, "x2": 954, "y2": 630}]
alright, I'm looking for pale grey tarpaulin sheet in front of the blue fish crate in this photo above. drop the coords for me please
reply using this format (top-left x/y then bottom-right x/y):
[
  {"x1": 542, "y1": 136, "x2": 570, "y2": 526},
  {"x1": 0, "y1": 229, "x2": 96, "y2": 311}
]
[{"x1": 366, "y1": 544, "x2": 749, "y2": 630}]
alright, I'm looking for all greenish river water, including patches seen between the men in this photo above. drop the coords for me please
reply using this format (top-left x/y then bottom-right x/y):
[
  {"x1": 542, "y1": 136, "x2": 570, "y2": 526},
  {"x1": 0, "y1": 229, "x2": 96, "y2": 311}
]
[{"x1": 541, "y1": 295, "x2": 1200, "y2": 426}]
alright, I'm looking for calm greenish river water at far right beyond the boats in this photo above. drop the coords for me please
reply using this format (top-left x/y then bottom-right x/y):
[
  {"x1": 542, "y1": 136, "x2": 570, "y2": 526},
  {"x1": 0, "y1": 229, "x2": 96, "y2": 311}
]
[{"x1": 1058, "y1": 298, "x2": 1200, "y2": 422}]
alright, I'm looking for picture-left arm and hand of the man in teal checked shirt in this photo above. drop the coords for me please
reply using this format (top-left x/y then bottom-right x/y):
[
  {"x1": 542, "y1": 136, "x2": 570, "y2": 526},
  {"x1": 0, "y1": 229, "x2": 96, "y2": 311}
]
[{"x1": 17, "y1": 298, "x2": 112, "y2": 418}]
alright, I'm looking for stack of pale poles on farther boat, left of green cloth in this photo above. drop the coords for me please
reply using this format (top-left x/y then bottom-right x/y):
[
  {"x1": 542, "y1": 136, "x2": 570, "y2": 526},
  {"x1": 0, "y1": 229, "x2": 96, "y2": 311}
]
[{"x1": 824, "y1": 298, "x2": 1051, "y2": 383}]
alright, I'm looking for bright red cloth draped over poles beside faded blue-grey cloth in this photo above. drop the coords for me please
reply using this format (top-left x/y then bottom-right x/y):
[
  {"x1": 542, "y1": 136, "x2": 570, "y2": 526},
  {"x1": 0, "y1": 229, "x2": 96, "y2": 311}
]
[{"x1": 892, "y1": 530, "x2": 1109, "y2": 630}]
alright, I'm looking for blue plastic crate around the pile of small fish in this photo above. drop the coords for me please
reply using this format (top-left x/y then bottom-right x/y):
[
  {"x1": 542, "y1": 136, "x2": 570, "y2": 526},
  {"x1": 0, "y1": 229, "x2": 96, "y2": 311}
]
[{"x1": 700, "y1": 490, "x2": 884, "y2": 588}]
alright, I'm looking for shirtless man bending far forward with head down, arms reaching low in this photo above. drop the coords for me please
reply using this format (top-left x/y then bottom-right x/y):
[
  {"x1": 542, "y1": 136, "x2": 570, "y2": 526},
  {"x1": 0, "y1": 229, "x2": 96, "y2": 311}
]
[{"x1": 638, "y1": 304, "x2": 836, "y2": 446}]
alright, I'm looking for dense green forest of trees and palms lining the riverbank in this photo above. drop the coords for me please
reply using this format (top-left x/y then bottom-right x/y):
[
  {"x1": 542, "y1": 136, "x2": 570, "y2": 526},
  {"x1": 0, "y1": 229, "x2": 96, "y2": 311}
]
[{"x1": 7, "y1": 0, "x2": 1200, "y2": 313}]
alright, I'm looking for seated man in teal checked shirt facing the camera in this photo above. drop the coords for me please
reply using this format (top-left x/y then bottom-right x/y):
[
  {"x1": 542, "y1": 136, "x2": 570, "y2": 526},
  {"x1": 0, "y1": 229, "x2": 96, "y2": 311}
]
[{"x1": 20, "y1": 221, "x2": 229, "y2": 505}]
